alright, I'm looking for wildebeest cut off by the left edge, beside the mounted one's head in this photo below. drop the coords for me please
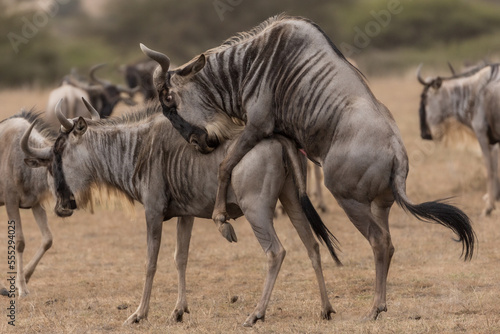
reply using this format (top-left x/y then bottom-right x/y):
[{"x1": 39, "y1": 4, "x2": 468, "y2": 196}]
[{"x1": 0, "y1": 110, "x2": 55, "y2": 297}]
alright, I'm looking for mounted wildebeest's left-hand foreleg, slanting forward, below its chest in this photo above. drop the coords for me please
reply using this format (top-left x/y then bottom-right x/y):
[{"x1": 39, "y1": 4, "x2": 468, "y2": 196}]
[{"x1": 124, "y1": 210, "x2": 163, "y2": 325}]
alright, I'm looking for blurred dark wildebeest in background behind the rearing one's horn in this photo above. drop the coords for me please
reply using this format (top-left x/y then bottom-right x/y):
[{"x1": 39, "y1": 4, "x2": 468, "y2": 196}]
[{"x1": 120, "y1": 59, "x2": 157, "y2": 102}]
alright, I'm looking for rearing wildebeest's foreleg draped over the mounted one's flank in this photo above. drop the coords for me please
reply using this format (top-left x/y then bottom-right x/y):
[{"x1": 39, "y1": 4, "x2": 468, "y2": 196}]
[{"x1": 212, "y1": 124, "x2": 272, "y2": 242}]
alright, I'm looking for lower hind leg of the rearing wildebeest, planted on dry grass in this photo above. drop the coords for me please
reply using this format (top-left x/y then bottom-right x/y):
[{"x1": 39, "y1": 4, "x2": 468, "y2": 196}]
[{"x1": 338, "y1": 199, "x2": 394, "y2": 320}]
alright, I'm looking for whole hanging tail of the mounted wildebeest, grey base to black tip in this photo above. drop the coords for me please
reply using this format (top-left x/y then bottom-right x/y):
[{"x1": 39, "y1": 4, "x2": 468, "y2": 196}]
[{"x1": 276, "y1": 135, "x2": 342, "y2": 265}]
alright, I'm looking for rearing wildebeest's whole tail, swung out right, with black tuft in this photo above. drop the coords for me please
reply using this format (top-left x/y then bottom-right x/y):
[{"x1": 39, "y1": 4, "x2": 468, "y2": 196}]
[{"x1": 392, "y1": 153, "x2": 476, "y2": 261}]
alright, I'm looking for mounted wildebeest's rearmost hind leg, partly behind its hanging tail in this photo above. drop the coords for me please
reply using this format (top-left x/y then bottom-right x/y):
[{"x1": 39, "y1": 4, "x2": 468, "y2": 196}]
[{"x1": 280, "y1": 180, "x2": 335, "y2": 320}]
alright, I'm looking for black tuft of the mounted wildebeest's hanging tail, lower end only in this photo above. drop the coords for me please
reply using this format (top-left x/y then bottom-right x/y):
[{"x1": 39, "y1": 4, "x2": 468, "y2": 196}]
[{"x1": 300, "y1": 195, "x2": 342, "y2": 266}]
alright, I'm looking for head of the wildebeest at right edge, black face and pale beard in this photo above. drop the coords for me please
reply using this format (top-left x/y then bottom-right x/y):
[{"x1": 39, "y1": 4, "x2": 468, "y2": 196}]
[{"x1": 417, "y1": 64, "x2": 447, "y2": 140}]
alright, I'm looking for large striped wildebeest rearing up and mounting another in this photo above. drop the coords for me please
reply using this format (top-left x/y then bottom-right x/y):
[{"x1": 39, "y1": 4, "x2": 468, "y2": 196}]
[{"x1": 141, "y1": 15, "x2": 475, "y2": 319}]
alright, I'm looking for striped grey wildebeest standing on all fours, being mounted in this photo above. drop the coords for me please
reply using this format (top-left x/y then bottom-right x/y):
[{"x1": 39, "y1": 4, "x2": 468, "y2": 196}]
[{"x1": 25, "y1": 98, "x2": 340, "y2": 326}]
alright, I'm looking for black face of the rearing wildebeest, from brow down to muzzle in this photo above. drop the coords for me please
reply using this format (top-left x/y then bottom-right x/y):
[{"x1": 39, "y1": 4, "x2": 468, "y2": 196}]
[{"x1": 159, "y1": 90, "x2": 220, "y2": 153}]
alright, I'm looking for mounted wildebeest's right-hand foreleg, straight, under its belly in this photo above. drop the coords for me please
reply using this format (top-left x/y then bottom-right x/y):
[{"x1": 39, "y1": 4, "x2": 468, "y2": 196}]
[{"x1": 171, "y1": 217, "x2": 194, "y2": 322}]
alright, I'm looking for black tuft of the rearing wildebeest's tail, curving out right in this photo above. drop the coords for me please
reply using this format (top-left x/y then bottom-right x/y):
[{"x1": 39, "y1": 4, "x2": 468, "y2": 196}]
[{"x1": 396, "y1": 196, "x2": 476, "y2": 261}]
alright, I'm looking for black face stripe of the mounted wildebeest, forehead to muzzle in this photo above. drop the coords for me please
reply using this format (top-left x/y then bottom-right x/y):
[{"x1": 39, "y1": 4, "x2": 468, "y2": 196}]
[{"x1": 52, "y1": 134, "x2": 77, "y2": 217}]
